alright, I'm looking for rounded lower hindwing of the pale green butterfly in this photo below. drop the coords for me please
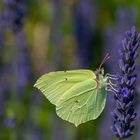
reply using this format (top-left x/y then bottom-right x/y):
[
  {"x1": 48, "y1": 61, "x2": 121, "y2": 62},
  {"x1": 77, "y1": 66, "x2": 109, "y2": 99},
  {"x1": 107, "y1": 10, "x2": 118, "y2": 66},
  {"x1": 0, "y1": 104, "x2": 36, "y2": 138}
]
[{"x1": 56, "y1": 79, "x2": 107, "y2": 126}]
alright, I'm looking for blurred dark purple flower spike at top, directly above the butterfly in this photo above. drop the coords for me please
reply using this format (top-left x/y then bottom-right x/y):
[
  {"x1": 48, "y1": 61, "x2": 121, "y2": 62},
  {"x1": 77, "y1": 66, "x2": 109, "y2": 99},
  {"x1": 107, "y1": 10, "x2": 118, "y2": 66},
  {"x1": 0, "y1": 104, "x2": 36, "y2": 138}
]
[{"x1": 73, "y1": 0, "x2": 97, "y2": 67}]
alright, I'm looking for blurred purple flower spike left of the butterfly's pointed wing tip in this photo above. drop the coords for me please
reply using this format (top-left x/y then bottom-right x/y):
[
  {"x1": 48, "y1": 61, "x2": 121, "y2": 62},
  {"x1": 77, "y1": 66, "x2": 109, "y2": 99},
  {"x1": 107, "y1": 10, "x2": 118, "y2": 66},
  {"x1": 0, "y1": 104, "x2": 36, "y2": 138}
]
[{"x1": 16, "y1": 31, "x2": 32, "y2": 95}]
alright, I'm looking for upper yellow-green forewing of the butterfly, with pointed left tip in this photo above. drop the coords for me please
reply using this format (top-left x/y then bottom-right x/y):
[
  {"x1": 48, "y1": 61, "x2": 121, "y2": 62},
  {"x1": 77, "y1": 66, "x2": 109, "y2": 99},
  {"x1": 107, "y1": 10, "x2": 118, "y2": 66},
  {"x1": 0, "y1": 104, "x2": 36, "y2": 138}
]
[{"x1": 34, "y1": 70, "x2": 96, "y2": 106}]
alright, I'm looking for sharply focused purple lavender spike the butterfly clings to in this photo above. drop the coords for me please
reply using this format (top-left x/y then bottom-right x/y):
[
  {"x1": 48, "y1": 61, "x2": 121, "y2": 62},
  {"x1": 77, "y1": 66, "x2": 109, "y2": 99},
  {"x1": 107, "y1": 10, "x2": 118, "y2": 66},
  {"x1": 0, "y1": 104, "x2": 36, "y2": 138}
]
[{"x1": 111, "y1": 27, "x2": 140, "y2": 140}]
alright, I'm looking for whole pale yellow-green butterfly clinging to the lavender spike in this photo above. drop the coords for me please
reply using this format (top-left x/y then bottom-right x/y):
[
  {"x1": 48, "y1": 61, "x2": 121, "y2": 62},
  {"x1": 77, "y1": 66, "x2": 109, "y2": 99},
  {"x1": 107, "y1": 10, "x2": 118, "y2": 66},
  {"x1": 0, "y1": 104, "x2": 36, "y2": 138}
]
[{"x1": 34, "y1": 54, "x2": 116, "y2": 127}]
